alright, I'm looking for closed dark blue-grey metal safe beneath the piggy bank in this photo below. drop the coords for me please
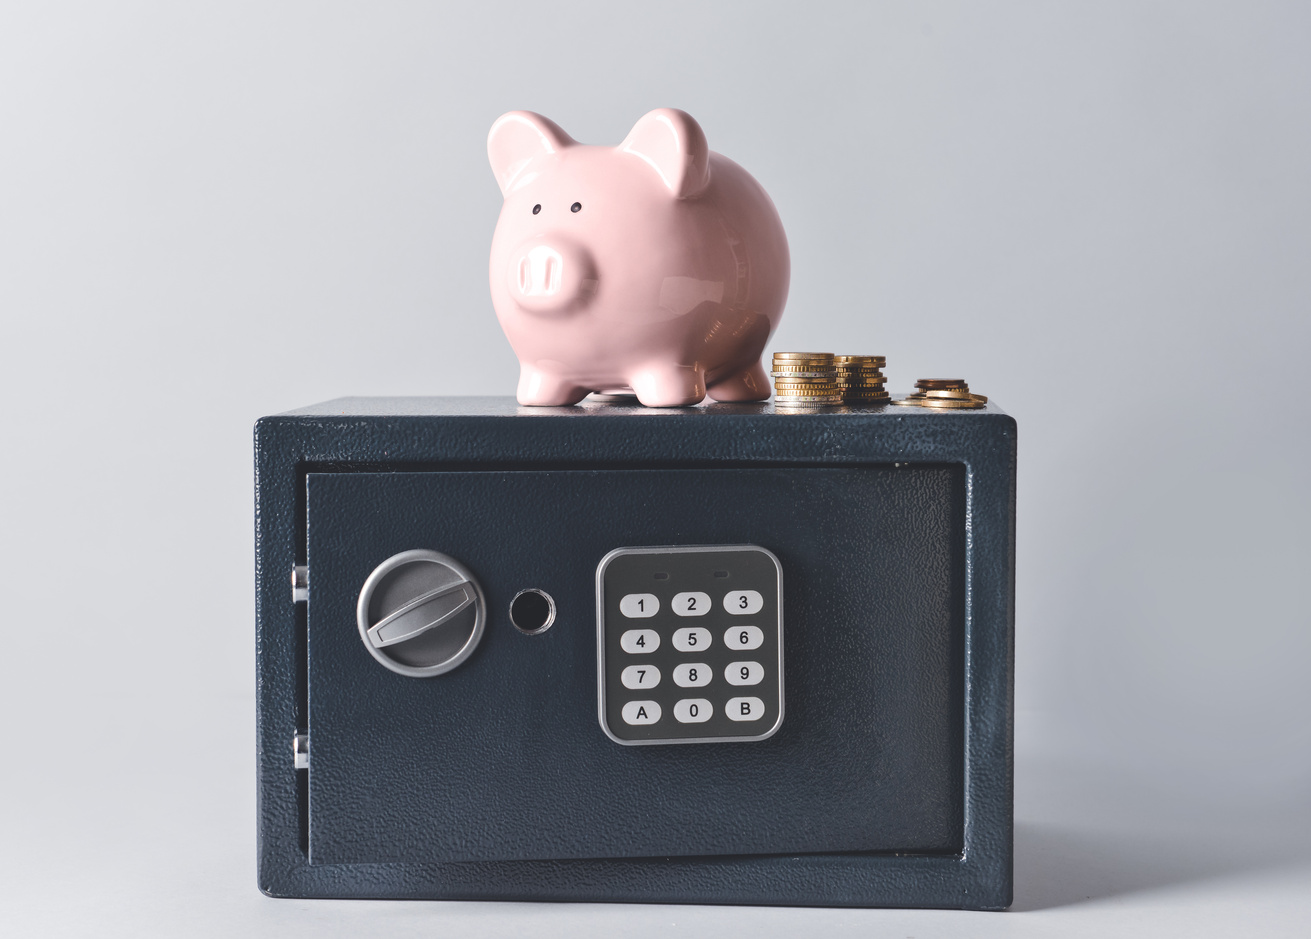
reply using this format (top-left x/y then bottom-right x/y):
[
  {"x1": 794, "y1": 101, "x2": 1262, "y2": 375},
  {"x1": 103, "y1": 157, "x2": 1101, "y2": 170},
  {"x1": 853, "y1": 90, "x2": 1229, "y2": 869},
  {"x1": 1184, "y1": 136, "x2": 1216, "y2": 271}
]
[{"x1": 256, "y1": 397, "x2": 1016, "y2": 909}]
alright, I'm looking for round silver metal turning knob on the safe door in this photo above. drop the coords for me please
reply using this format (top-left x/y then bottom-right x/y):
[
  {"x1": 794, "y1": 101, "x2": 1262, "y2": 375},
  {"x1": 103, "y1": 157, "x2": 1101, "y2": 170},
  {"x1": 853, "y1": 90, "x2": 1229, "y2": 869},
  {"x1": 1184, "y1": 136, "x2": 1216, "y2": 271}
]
[{"x1": 355, "y1": 549, "x2": 486, "y2": 678}]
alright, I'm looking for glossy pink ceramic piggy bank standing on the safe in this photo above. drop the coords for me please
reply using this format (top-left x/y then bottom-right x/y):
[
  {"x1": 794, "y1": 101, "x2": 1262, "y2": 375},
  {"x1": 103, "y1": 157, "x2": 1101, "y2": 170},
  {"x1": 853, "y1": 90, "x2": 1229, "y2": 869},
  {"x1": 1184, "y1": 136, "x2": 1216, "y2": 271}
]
[{"x1": 488, "y1": 108, "x2": 791, "y2": 407}]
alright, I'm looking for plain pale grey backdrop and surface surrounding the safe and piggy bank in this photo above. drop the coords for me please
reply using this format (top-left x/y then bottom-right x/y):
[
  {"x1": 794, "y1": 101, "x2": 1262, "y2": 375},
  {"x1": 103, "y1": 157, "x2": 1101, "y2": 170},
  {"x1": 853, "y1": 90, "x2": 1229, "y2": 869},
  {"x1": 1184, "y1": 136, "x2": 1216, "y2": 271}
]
[{"x1": 0, "y1": 0, "x2": 1311, "y2": 939}]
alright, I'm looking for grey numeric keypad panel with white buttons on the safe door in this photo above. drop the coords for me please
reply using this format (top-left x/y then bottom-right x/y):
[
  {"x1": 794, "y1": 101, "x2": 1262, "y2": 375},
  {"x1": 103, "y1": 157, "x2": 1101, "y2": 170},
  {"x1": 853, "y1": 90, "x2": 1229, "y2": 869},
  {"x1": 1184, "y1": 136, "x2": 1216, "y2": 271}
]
[{"x1": 597, "y1": 544, "x2": 783, "y2": 744}]
